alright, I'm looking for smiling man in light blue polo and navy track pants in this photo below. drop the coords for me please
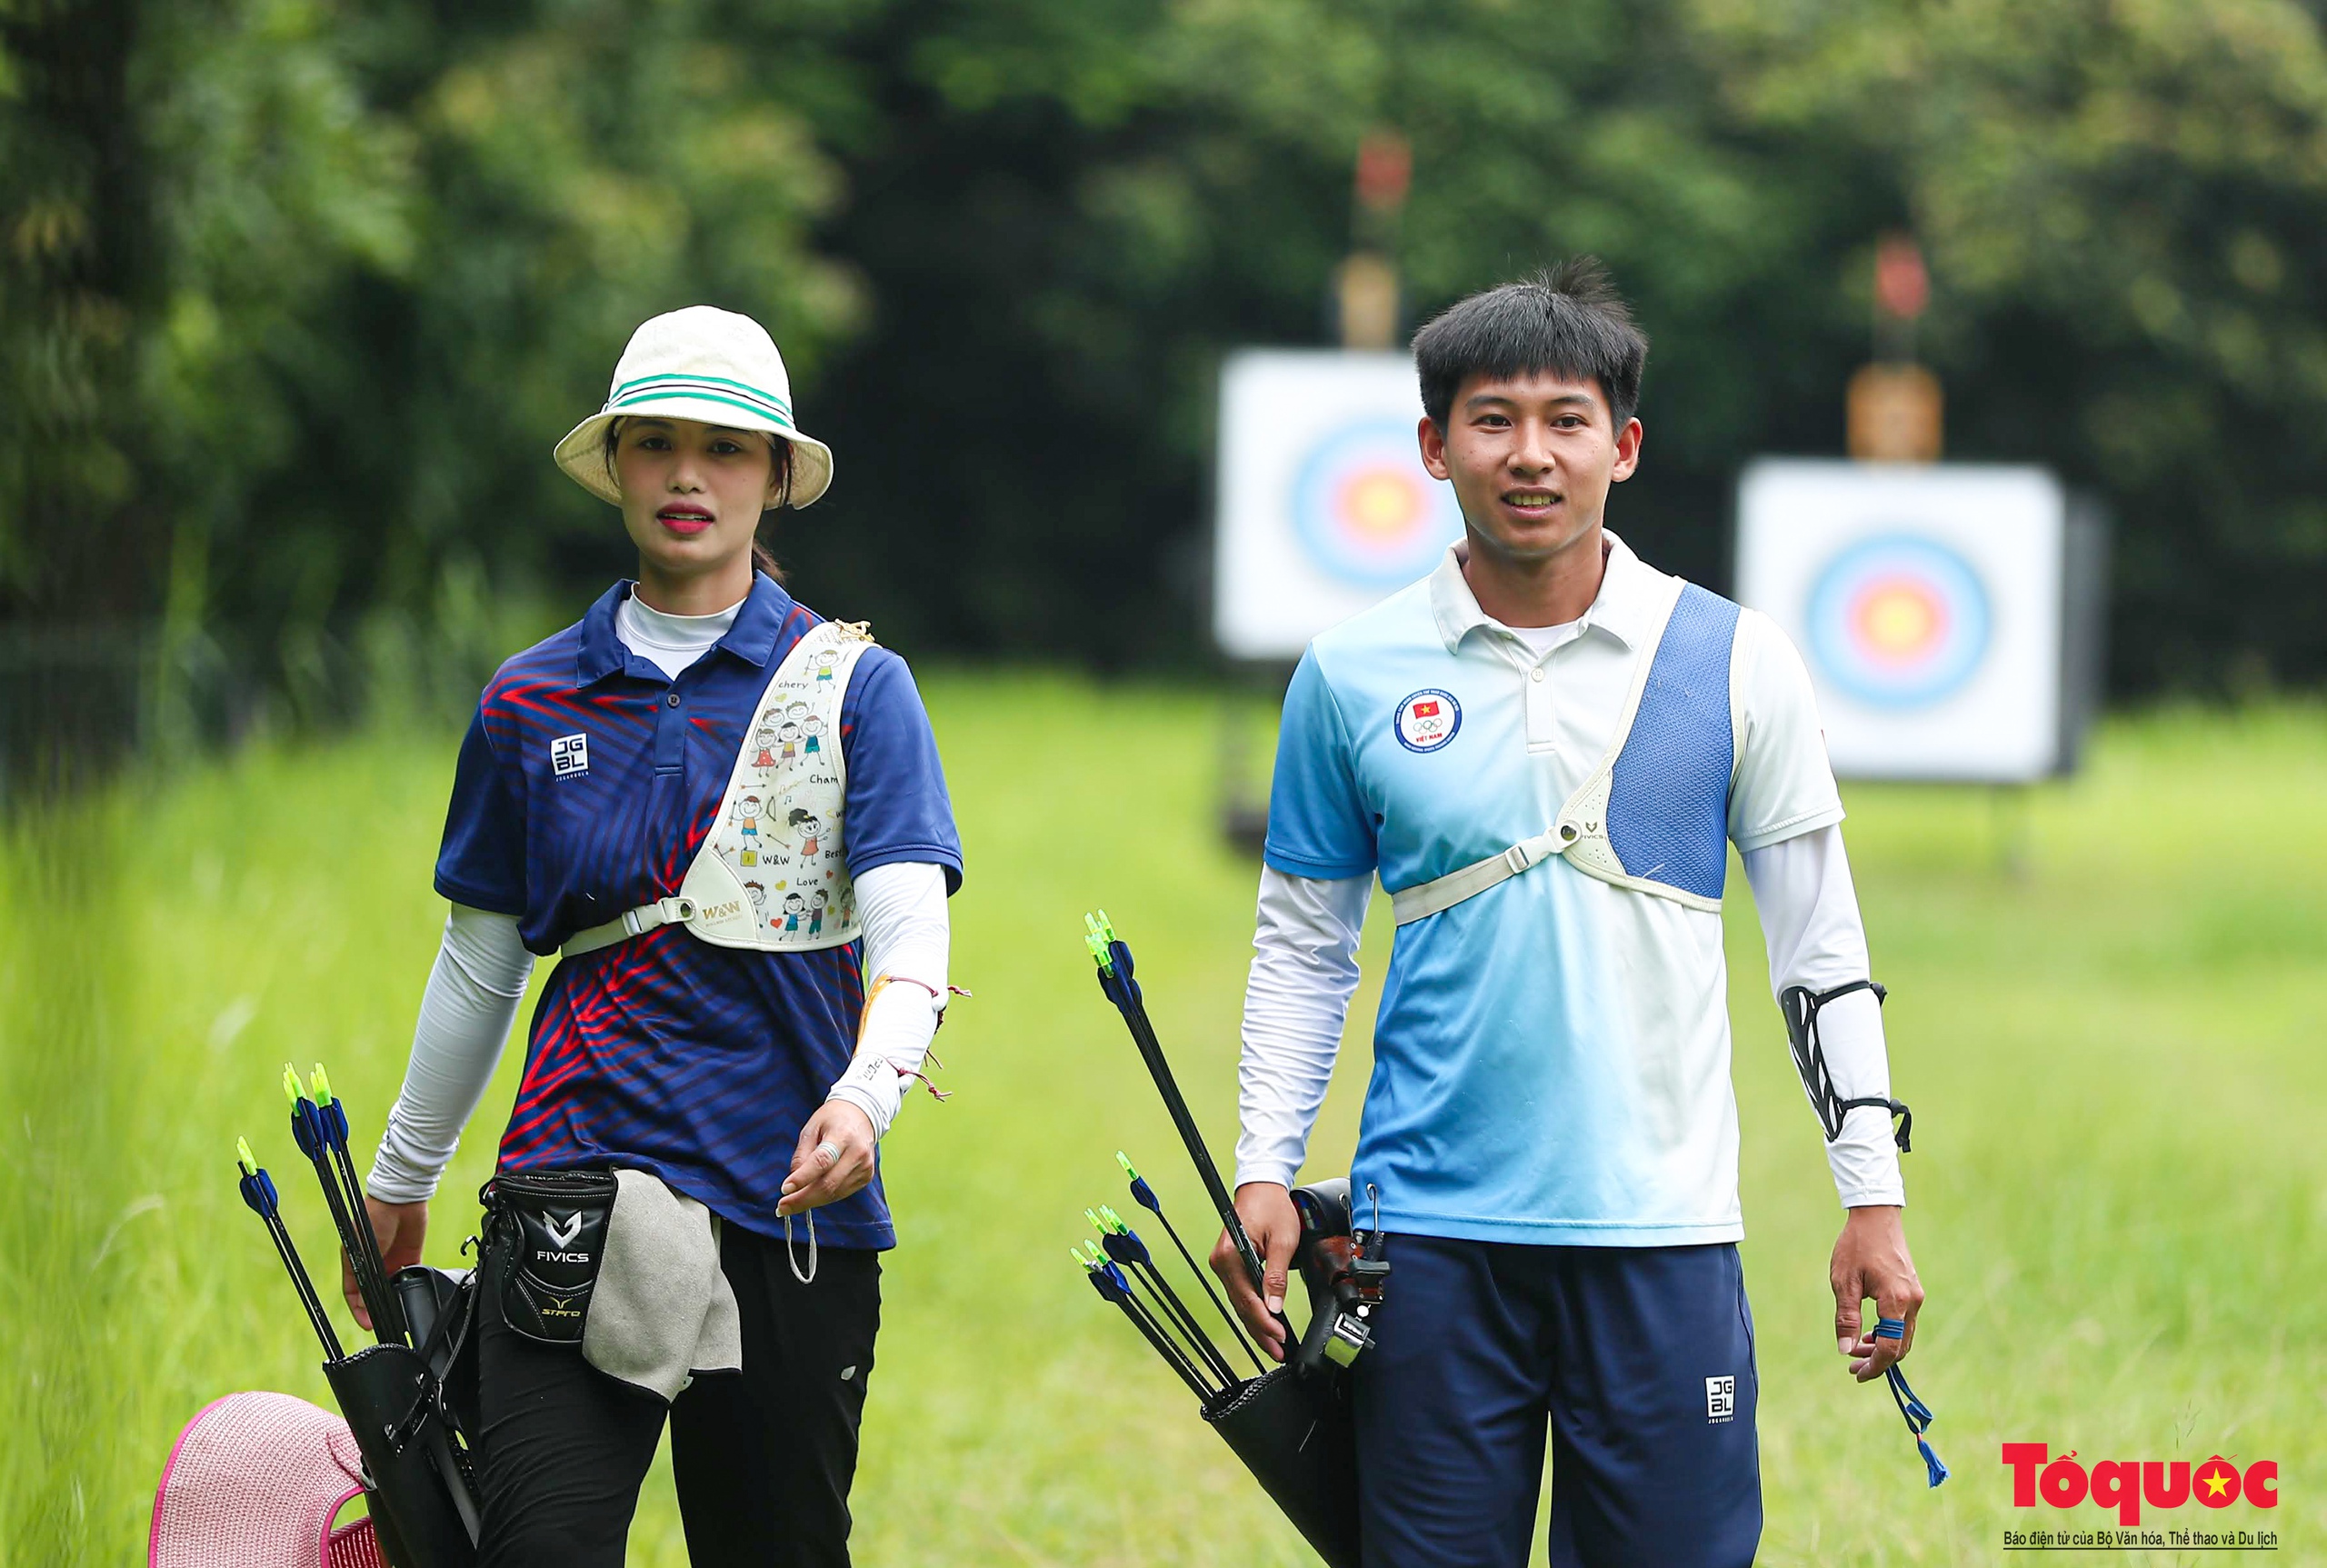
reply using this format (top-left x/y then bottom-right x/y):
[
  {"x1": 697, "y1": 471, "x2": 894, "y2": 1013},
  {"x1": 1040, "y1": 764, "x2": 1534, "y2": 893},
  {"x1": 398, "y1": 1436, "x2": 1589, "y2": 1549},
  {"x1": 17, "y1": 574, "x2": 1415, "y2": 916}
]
[{"x1": 1213, "y1": 261, "x2": 1923, "y2": 1568}]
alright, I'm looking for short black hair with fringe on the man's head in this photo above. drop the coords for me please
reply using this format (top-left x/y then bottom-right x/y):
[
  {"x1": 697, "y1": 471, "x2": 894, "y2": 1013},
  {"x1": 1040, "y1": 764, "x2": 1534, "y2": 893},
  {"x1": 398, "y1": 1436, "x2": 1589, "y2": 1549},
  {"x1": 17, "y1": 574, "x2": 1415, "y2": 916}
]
[{"x1": 1414, "y1": 256, "x2": 1647, "y2": 430}]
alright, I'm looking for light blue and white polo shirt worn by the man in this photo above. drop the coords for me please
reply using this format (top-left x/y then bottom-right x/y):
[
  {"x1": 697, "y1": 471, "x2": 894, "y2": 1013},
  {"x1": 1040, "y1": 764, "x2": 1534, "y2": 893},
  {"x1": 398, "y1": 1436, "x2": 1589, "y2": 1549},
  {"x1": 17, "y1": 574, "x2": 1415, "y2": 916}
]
[{"x1": 1266, "y1": 535, "x2": 1843, "y2": 1247}]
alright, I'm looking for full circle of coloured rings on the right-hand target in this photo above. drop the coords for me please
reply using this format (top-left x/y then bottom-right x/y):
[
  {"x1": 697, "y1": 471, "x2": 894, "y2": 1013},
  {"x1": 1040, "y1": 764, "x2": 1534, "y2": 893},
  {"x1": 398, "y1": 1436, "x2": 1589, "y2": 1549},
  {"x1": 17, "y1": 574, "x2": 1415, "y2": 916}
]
[{"x1": 1811, "y1": 533, "x2": 1994, "y2": 710}]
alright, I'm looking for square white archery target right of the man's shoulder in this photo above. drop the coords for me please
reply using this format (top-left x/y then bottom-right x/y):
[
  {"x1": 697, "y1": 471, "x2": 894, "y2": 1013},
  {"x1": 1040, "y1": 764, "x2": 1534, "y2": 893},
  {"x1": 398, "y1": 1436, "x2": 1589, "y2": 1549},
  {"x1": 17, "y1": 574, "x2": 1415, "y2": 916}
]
[{"x1": 1738, "y1": 461, "x2": 2066, "y2": 784}]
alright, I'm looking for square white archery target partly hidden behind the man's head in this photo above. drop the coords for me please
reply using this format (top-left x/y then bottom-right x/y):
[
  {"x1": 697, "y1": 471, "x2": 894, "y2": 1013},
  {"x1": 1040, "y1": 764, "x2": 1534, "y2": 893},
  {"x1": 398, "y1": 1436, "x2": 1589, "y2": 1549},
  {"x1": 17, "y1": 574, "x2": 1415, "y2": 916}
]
[{"x1": 1213, "y1": 351, "x2": 1462, "y2": 661}]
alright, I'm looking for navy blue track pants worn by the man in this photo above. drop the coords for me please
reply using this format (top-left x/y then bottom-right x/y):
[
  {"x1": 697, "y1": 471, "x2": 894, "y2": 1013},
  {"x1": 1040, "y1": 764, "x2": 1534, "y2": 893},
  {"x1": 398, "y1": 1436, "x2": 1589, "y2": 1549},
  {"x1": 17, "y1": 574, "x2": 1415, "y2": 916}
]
[{"x1": 1356, "y1": 1235, "x2": 1762, "y2": 1568}]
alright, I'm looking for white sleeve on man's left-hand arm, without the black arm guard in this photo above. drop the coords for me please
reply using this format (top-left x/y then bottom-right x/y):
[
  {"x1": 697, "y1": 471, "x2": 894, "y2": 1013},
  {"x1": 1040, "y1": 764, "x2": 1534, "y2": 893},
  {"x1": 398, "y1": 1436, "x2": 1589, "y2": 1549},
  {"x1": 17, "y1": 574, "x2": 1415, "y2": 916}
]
[{"x1": 1235, "y1": 865, "x2": 1373, "y2": 1186}]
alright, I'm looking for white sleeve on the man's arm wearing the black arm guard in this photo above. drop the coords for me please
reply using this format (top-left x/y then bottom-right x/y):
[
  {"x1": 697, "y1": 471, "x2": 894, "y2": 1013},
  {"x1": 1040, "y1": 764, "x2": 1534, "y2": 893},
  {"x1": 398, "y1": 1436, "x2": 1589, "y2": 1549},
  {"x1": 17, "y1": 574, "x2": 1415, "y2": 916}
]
[{"x1": 1745, "y1": 826, "x2": 1906, "y2": 1210}]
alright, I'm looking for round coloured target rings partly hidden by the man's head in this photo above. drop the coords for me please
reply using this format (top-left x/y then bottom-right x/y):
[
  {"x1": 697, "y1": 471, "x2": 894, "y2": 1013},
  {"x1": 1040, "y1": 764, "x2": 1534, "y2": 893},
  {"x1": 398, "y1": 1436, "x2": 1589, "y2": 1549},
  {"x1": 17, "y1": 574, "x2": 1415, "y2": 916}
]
[{"x1": 1292, "y1": 419, "x2": 1462, "y2": 589}]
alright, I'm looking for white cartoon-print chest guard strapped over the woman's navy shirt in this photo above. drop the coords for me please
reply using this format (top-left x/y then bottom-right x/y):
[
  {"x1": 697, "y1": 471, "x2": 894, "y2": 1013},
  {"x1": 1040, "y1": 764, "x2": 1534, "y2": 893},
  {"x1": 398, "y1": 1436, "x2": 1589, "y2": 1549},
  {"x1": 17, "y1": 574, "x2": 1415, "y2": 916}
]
[{"x1": 558, "y1": 621, "x2": 873, "y2": 958}]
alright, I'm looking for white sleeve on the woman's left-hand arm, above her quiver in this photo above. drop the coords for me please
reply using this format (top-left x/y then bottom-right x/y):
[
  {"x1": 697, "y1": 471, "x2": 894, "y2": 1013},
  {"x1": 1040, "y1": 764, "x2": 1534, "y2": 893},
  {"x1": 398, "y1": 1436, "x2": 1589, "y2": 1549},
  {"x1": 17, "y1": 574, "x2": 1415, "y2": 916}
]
[{"x1": 365, "y1": 905, "x2": 533, "y2": 1203}]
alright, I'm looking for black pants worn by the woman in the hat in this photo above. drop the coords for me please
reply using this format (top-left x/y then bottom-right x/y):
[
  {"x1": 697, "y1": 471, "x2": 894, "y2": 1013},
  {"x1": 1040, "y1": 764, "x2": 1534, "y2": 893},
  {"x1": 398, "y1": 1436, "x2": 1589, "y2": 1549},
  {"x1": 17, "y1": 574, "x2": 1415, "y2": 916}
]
[{"x1": 477, "y1": 1226, "x2": 880, "y2": 1568}]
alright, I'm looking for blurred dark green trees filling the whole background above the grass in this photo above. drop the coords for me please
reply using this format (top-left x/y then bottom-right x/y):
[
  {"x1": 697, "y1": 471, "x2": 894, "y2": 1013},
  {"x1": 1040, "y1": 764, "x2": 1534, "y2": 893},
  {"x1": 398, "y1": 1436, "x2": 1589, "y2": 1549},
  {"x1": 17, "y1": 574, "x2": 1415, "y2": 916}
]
[{"x1": 0, "y1": 0, "x2": 2327, "y2": 712}]
